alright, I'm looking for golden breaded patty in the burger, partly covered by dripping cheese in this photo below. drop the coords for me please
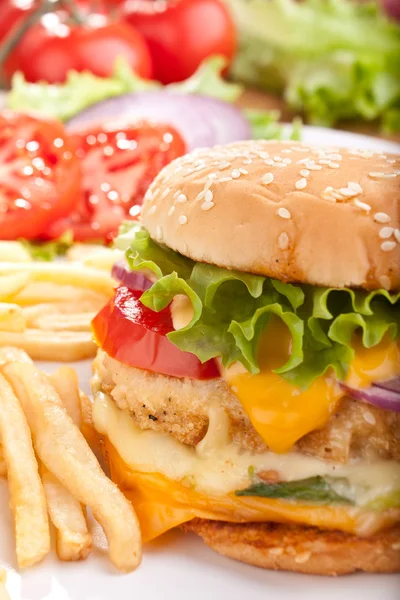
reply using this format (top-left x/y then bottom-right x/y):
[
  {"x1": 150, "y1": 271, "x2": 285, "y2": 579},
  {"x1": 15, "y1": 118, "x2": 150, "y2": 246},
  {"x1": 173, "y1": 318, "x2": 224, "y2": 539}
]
[{"x1": 95, "y1": 351, "x2": 400, "y2": 463}]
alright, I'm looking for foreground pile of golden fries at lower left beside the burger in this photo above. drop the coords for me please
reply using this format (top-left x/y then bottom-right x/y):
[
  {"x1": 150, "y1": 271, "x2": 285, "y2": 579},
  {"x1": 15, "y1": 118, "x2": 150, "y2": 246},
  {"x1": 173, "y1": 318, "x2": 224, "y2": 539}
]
[{"x1": 0, "y1": 346, "x2": 141, "y2": 572}]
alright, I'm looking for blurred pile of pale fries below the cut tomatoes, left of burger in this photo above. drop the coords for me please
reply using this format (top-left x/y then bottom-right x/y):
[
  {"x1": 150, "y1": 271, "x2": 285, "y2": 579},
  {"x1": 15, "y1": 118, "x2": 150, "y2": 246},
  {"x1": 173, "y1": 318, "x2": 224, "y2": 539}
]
[{"x1": 0, "y1": 242, "x2": 120, "y2": 362}]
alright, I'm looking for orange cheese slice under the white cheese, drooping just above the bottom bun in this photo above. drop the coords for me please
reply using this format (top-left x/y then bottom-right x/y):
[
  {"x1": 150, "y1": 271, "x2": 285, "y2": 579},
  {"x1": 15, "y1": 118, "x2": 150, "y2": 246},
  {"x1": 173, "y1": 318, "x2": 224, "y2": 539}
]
[{"x1": 106, "y1": 441, "x2": 399, "y2": 542}]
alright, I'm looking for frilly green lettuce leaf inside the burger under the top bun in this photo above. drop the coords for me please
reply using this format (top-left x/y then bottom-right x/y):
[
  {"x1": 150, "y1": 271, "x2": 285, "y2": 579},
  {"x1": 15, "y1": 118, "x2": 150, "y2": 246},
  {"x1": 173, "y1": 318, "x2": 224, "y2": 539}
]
[{"x1": 120, "y1": 223, "x2": 400, "y2": 389}]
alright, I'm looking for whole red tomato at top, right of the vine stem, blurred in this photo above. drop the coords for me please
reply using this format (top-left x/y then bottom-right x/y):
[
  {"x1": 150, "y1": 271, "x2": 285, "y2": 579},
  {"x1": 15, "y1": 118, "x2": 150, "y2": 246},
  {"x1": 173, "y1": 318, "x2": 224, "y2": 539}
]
[{"x1": 124, "y1": 0, "x2": 236, "y2": 84}]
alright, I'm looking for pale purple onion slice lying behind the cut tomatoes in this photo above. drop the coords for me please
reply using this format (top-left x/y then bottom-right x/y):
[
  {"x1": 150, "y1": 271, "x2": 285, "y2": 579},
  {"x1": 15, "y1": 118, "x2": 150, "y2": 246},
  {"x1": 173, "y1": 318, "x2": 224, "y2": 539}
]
[{"x1": 67, "y1": 91, "x2": 252, "y2": 150}]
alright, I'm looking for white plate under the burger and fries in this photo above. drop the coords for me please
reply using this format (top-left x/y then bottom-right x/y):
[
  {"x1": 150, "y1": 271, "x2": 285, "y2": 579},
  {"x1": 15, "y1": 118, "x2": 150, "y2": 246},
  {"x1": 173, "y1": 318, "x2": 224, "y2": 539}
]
[{"x1": 0, "y1": 127, "x2": 400, "y2": 600}]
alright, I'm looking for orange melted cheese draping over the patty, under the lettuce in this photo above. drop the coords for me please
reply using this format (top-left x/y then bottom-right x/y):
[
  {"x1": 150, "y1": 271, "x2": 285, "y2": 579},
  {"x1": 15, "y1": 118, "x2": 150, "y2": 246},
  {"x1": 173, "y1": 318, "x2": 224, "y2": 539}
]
[{"x1": 222, "y1": 320, "x2": 400, "y2": 452}]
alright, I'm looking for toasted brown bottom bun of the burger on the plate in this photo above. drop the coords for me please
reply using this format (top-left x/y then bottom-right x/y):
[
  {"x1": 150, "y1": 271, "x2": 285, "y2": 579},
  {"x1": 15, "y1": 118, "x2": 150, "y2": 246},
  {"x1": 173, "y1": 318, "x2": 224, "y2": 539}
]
[{"x1": 183, "y1": 519, "x2": 400, "y2": 575}]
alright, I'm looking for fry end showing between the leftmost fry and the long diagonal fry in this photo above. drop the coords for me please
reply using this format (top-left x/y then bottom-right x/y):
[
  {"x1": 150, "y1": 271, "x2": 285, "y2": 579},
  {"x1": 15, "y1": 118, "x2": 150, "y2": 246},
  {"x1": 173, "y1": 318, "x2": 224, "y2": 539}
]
[{"x1": 41, "y1": 465, "x2": 92, "y2": 561}]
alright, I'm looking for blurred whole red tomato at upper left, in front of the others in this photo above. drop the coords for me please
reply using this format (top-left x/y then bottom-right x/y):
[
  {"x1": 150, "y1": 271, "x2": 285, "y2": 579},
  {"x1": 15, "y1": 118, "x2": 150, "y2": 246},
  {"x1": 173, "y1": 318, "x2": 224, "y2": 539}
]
[{"x1": 4, "y1": 11, "x2": 152, "y2": 83}]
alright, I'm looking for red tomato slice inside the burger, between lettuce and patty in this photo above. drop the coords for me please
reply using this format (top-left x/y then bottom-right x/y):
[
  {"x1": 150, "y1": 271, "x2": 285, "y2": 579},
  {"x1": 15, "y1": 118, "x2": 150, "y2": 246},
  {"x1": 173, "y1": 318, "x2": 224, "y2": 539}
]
[{"x1": 92, "y1": 286, "x2": 220, "y2": 379}]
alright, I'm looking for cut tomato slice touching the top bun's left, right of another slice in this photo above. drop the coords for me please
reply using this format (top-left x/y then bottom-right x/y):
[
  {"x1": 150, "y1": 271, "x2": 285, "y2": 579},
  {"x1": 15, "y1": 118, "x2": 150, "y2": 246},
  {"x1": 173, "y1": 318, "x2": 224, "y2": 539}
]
[{"x1": 49, "y1": 123, "x2": 186, "y2": 241}]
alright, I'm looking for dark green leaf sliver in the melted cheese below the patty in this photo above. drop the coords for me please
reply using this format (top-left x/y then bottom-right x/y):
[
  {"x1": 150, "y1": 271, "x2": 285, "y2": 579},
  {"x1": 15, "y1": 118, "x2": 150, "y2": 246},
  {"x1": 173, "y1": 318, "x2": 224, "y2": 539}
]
[{"x1": 236, "y1": 476, "x2": 352, "y2": 504}]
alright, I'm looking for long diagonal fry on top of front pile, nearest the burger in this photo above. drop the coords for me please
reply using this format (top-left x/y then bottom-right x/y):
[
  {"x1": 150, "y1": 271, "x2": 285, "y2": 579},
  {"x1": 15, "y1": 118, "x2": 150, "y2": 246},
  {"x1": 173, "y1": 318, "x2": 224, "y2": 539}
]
[{"x1": 1, "y1": 363, "x2": 141, "y2": 572}]
